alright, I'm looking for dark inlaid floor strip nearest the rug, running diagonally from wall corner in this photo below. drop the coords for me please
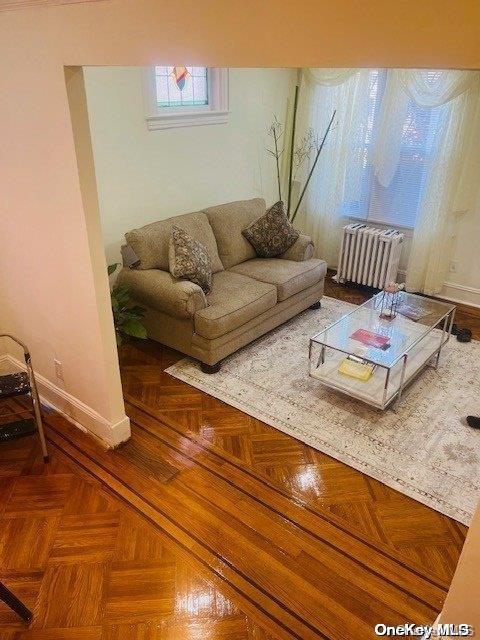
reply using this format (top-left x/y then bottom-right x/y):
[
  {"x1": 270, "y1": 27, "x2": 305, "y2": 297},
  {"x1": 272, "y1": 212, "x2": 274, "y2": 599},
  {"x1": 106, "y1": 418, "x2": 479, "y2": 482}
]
[{"x1": 125, "y1": 394, "x2": 449, "y2": 593}]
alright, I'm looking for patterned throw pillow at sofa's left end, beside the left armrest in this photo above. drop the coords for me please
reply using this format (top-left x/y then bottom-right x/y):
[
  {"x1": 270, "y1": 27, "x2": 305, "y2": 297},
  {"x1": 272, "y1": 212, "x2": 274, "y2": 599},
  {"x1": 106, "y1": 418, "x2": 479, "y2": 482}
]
[{"x1": 169, "y1": 226, "x2": 212, "y2": 293}]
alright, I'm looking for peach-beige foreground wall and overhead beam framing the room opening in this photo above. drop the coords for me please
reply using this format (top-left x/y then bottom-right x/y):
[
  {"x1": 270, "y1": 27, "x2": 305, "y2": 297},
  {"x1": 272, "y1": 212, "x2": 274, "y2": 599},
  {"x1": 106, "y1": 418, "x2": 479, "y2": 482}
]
[{"x1": 0, "y1": 0, "x2": 480, "y2": 628}]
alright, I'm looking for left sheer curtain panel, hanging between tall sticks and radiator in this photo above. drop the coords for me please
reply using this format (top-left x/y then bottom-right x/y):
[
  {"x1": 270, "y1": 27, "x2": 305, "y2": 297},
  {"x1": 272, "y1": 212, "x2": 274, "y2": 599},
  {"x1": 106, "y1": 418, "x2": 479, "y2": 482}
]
[{"x1": 296, "y1": 69, "x2": 369, "y2": 264}]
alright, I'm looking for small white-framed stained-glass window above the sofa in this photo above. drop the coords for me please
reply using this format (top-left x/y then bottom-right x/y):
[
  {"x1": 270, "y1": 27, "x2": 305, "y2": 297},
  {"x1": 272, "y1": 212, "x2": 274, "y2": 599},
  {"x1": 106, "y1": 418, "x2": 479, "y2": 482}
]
[{"x1": 145, "y1": 66, "x2": 228, "y2": 130}]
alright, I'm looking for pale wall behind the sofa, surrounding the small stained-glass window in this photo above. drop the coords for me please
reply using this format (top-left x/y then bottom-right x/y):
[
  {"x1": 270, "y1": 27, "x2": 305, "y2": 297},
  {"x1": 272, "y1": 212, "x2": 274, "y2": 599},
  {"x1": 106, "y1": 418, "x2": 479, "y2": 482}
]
[{"x1": 85, "y1": 67, "x2": 296, "y2": 262}]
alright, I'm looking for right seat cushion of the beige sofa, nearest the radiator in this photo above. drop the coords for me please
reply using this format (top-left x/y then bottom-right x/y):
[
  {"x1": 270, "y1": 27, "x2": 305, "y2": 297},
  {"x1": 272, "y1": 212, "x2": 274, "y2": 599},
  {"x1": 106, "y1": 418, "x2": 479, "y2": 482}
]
[{"x1": 229, "y1": 258, "x2": 327, "y2": 301}]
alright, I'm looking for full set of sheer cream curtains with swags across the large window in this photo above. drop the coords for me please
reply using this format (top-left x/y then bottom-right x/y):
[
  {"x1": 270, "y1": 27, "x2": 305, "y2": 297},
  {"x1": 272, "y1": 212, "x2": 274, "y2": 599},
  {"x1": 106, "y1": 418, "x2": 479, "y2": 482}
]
[{"x1": 299, "y1": 69, "x2": 480, "y2": 294}]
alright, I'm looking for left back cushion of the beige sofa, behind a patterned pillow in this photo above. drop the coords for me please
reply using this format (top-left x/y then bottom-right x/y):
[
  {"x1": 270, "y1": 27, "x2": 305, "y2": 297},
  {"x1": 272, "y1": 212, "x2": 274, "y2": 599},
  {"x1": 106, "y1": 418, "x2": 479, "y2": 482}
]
[{"x1": 125, "y1": 211, "x2": 223, "y2": 273}]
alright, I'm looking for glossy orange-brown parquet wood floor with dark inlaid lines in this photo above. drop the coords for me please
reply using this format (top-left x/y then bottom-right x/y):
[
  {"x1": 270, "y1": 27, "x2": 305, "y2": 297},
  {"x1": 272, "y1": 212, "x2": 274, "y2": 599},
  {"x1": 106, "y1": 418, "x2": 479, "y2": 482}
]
[{"x1": 0, "y1": 282, "x2": 480, "y2": 640}]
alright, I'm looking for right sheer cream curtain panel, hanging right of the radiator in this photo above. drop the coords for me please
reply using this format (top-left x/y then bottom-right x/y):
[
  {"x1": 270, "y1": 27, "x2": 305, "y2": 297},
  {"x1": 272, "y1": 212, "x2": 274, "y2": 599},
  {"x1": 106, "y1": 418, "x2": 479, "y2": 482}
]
[{"x1": 395, "y1": 70, "x2": 480, "y2": 295}]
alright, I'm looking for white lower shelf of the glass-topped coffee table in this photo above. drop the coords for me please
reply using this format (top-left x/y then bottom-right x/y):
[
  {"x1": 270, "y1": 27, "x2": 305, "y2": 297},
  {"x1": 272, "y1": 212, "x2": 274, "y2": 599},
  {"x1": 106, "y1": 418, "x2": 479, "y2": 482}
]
[{"x1": 310, "y1": 332, "x2": 441, "y2": 409}]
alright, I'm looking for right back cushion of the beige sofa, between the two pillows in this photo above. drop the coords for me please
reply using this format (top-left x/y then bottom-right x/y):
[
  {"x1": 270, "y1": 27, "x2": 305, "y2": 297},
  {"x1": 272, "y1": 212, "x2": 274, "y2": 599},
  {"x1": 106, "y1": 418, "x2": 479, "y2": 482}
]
[{"x1": 205, "y1": 198, "x2": 265, "y2": 269}]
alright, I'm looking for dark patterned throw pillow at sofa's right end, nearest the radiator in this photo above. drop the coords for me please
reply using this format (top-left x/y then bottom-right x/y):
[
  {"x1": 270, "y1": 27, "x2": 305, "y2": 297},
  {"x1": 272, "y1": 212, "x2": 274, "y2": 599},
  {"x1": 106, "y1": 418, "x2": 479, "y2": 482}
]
[{"x1": 242, "y1": 202, "x2": 300, "y2": 258}]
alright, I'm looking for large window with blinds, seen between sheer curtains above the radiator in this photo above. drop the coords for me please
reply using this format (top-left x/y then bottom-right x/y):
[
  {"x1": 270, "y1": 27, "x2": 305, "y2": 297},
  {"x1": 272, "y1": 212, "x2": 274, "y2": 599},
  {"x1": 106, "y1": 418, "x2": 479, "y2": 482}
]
[{"x1": 339, "y1": 69, "x2": 448, "y2": 228}]
